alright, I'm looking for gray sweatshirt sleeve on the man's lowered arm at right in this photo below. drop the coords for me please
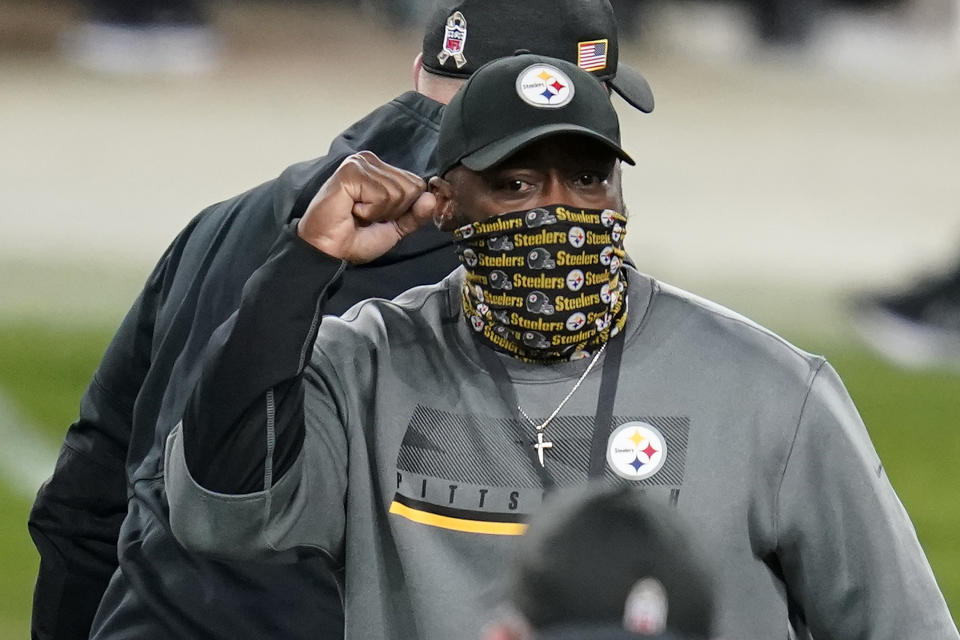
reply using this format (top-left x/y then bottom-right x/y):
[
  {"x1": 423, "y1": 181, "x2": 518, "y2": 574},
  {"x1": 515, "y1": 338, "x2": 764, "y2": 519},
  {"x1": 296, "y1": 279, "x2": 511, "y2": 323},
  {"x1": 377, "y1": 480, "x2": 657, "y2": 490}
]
[{"x1": 777, "y1": 364, "x2": 958, "y2": 640}]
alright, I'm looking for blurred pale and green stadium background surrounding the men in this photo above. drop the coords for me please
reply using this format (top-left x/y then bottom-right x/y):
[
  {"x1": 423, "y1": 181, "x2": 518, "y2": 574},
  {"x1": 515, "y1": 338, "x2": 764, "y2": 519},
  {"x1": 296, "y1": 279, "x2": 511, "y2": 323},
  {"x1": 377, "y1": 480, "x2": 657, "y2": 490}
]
[{"x1": 0, "y1": 0, "x2": 960, "y2": 638}]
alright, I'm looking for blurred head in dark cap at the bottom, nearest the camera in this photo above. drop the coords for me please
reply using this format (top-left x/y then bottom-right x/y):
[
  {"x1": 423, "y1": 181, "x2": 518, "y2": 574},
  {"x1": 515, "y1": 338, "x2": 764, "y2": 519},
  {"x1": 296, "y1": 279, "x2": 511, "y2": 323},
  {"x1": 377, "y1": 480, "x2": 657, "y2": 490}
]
[{"x1": 484, "y1": 486, "x2": 714, "y2": 640}]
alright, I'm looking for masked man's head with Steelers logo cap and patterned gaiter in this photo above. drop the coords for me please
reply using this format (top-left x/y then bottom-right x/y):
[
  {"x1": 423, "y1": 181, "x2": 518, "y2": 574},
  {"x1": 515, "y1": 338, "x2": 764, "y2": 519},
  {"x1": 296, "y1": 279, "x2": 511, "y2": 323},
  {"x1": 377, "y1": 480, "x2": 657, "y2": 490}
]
[{"x1": 430, "y1": 54, "x2": 633, "y2": 362}]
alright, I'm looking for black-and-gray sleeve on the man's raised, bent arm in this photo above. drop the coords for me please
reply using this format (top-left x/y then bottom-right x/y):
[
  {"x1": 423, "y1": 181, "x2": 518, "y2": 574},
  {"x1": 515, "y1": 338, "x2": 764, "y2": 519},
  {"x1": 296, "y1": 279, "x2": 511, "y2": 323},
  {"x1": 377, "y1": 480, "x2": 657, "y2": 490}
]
[{"x1": 164, "y1": 220, "x2": 346, "y2": 559}]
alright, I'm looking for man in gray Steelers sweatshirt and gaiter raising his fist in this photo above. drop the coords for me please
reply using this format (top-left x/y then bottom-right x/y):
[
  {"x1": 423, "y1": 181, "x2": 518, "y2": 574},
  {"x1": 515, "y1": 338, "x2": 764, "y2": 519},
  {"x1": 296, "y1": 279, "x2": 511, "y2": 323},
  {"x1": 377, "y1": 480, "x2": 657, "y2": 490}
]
[{"x1": 165, "y1": 54, "x2": 960, "y2": 640}]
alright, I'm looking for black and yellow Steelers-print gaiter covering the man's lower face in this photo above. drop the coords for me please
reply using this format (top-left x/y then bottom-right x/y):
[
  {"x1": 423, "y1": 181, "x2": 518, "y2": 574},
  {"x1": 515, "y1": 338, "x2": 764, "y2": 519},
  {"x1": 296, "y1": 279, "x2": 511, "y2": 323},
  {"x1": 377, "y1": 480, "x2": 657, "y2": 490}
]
[{"x1": 453, "y1": 204, "x2": 627, "y2": 362}]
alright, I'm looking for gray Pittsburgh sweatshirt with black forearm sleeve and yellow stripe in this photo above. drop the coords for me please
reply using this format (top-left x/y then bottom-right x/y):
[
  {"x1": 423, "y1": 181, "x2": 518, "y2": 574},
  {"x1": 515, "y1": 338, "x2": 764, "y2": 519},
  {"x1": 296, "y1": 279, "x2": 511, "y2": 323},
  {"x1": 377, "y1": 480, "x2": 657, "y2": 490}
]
[{"x1": 165, "y1": 229, "x2": 960, "y2": 640}]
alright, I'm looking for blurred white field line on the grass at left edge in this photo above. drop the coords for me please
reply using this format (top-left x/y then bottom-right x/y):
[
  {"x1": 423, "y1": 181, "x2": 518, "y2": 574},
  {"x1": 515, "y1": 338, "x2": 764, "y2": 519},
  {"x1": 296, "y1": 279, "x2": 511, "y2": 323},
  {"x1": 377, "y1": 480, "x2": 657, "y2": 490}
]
[{"x1": 0, "y1": 392, "x2": 58, "y2": 500}]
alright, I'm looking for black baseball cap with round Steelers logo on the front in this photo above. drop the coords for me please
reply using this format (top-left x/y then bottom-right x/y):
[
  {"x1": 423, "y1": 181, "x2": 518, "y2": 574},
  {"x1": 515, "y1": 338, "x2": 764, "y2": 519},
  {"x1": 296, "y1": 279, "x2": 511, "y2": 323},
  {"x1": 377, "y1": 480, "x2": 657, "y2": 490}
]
[{"x1": 436, "y1": 53, "x2": 635, "y2": 176}]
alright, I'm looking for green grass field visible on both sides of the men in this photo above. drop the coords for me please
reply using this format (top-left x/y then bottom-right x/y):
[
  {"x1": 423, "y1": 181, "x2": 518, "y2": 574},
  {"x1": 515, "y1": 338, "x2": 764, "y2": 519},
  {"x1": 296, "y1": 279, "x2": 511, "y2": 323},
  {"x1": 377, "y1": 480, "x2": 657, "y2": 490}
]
[{"x1": 0, "y1": 320, "x2": 960, "y2": 638}]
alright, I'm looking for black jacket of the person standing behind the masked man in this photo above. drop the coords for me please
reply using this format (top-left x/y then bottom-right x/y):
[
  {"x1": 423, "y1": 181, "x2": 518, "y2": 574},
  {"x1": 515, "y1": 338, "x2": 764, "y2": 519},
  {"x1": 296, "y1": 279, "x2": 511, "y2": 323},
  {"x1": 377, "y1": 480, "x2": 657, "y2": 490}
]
[{"x1": 29, "y1": 92, "x2": 458, "y2": 640}]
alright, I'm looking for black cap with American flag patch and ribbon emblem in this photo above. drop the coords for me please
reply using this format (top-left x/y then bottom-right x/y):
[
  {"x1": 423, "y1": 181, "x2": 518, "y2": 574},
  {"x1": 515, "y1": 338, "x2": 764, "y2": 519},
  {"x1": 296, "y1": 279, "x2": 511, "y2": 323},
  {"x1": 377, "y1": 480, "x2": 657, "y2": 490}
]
[{"x1": 422, "y1": 0, "x2": 653, "y2": 113}]
